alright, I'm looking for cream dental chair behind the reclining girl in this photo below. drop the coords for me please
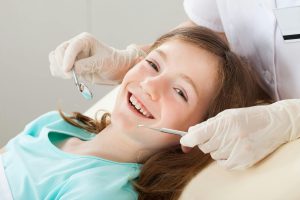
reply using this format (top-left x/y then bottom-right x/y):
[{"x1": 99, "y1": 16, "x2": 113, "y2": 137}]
[{"x1": 85, "y1": 87, "x2": 300, "y2": 200}]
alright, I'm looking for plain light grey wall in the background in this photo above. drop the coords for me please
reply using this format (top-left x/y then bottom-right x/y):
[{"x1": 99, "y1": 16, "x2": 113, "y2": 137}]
[{"x1": 0, "y1": 0, "x2": 187, "y2": 147}]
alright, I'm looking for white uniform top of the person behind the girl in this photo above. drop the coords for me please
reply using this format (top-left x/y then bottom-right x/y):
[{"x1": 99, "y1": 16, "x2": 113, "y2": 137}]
[{"x1": 184, "y1": 0, "x2": 300, "y2": 100}]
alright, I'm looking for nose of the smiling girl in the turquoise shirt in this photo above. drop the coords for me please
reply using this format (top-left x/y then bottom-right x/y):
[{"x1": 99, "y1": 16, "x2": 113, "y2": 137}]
[{"x1": 140, "y1": 76, "x2": 166, "y2": 101}]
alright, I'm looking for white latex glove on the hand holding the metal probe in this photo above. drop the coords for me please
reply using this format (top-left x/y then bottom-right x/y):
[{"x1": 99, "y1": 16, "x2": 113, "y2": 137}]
[{"x1": 180, "y1": 99, "x2": 300, "y2": 169}]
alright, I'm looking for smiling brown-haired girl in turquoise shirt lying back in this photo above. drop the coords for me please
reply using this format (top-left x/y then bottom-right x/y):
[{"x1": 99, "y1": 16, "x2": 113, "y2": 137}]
[{"x1": 0, "y1": 27, "x2": 270, "y2": 200}]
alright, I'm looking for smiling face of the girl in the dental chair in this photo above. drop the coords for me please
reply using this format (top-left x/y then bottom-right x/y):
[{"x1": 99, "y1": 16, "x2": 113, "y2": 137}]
[{"x1": 111, "y1": 39, "x2": 218, "y2": 150}]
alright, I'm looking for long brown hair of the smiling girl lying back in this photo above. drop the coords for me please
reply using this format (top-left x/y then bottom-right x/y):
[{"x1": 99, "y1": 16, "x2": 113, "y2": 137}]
[{"x1": 59, "y1": 27, "x2": 270, "y2": 200}]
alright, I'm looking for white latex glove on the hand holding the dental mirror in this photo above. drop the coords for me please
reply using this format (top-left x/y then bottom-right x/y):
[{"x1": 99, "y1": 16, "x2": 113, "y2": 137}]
[{"x1": 49, "y1": 33, "x2": 146, "y2": 84}]
